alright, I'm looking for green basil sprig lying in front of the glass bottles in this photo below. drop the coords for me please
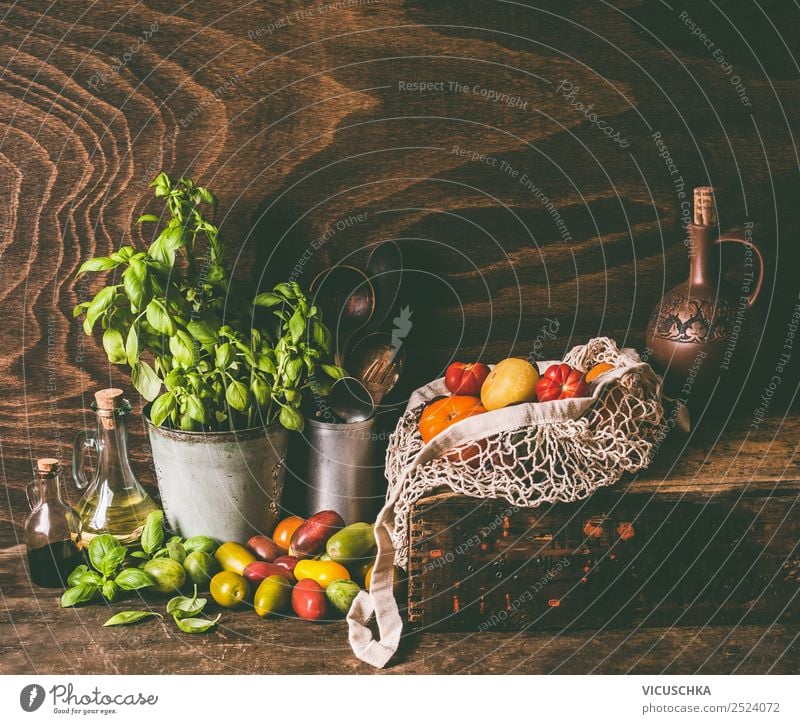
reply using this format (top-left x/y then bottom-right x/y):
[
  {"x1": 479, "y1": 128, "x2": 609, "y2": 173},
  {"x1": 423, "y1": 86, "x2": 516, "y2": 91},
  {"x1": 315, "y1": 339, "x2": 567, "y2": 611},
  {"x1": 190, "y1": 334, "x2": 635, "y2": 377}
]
[{"x1": 61, "y1": 533, "x2": 155, "y2": 608}]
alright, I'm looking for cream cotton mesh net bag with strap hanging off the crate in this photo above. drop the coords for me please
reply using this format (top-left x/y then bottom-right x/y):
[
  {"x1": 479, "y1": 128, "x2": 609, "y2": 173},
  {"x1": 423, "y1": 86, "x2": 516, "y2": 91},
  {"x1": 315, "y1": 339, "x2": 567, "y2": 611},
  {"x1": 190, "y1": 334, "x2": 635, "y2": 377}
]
[{"x1": 348, "y1": 337, "x2": 665, "y2": 667}]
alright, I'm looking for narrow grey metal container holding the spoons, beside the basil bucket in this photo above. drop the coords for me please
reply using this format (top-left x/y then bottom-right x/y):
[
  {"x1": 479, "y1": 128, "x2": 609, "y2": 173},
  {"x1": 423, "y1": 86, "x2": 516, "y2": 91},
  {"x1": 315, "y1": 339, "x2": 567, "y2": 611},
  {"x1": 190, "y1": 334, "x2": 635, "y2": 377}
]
[{"x1": 295, "y1": 416, "x2": 386, "y2": 525}]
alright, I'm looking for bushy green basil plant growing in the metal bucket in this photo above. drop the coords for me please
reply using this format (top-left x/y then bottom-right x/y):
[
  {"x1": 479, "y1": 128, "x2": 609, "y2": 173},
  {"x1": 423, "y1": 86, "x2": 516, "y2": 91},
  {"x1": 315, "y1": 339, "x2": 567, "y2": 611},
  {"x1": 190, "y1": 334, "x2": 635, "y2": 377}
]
[{"x1": 74, "y1": 173, "x2": 344, "y2": 431}]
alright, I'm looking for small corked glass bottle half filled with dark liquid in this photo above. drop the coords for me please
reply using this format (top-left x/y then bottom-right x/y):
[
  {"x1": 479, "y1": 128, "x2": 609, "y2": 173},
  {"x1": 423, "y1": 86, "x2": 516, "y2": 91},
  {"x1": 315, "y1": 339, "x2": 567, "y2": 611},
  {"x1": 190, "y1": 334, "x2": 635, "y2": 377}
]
[{"x1": 25, "y1": 458, "x2": 83, "y2": 588}]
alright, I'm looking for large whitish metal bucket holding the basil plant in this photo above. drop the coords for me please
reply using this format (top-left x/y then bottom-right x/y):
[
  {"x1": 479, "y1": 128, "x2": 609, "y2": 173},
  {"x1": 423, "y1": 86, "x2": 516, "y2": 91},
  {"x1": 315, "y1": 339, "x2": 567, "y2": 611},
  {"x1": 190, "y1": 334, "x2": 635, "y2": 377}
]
[{"x1": 144, "y1": 409, "x2": 288, "y2": 543}]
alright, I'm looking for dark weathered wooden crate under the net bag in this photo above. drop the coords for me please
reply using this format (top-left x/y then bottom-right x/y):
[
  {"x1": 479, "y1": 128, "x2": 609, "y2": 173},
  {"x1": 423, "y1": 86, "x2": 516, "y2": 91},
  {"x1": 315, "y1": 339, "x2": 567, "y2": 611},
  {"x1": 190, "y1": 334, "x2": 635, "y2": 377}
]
[{"x1": 408, "y1": 422, "x2": 800, "y2": 631}]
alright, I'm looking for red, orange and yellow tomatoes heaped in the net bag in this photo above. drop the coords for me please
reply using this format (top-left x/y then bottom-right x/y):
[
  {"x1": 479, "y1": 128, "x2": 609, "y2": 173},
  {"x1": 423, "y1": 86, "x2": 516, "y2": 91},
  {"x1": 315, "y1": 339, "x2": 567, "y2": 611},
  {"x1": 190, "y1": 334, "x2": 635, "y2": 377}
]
[{"x1": 419, "y1": 357, "x2": 613, "y2": 443}]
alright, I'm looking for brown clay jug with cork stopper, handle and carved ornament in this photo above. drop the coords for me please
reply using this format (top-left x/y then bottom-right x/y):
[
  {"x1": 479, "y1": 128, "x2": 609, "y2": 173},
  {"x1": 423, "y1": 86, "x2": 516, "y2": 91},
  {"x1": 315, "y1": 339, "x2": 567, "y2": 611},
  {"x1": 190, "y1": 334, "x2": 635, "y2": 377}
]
[{"x1": 646, "y1": 186, "x2": 764, "y2": 407}]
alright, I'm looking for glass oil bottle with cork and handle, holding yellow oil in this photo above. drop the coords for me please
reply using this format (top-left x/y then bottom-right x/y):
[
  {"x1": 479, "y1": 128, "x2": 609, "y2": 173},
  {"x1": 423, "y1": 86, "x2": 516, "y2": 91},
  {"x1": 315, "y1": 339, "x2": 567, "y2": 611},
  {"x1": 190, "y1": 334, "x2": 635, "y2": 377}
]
[{"x1": 72, "y1": 387, "x2": 158, "y2": 545}]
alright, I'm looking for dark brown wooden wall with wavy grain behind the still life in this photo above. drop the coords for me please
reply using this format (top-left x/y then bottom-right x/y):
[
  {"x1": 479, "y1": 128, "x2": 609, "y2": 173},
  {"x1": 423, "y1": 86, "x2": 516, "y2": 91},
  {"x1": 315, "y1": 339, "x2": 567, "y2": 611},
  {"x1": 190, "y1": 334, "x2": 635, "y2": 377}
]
[{"x1": 0, "y1": 0, "x2": 800, "y2": 543}]
